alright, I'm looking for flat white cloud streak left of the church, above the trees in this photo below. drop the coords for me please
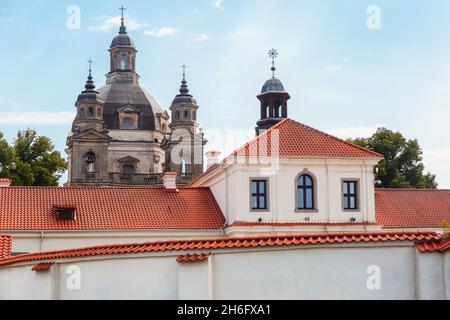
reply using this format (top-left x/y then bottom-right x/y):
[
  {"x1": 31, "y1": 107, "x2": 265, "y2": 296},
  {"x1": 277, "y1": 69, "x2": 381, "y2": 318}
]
[{"x1": 0, "y1": 112, "x2": 75, "y2": 125}]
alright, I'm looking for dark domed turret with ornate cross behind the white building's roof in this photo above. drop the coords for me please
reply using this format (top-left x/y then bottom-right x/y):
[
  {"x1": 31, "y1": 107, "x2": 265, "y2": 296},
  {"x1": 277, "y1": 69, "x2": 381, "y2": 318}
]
[{"x1": 256, "y1": 49, "x2": 291, "y2": 135}]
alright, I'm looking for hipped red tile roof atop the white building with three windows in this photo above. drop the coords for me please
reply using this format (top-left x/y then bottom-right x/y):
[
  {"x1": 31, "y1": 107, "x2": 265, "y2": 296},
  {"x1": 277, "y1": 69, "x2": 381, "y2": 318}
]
[{"x1": 232, "y1": 119, "x2": 383, "y2": 160}]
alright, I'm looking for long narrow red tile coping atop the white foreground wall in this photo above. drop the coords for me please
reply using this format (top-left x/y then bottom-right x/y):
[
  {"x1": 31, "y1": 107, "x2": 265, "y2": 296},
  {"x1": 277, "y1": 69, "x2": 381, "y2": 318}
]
[{"x1": 0, "y1": 231, "x2": 441, "y2": 267}]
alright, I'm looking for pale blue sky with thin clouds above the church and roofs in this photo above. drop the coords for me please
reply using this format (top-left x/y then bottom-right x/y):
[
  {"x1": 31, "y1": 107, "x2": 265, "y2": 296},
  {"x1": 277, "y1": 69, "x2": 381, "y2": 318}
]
[{"x1": 0, "y1": 0, "x2": 450, "y2": 188}]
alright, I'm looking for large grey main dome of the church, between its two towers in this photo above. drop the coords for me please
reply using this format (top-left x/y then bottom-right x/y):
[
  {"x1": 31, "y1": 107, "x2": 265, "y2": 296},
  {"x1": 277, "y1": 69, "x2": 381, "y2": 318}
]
[{"x1": 98, "y1": 81, "x2": 165, "y2": 130}]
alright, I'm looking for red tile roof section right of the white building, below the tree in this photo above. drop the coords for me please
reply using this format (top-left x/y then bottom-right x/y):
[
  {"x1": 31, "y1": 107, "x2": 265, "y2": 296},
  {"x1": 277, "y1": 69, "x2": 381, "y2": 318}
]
[{"x1": 375, "y1": 189, "x2": 450, "y2": 229}]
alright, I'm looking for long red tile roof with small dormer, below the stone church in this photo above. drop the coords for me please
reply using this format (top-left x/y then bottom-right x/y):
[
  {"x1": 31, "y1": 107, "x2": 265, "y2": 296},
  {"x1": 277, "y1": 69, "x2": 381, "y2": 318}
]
[{"x1": 0, "y1": 187, "x2": 225, "y2": 231}]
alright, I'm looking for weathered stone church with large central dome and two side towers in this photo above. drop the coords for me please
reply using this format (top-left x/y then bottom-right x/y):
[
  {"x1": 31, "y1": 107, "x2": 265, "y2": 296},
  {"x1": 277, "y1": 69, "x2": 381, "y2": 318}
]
[{"x1": 66, "y1": 18, "x2": 206, "y2": 185}]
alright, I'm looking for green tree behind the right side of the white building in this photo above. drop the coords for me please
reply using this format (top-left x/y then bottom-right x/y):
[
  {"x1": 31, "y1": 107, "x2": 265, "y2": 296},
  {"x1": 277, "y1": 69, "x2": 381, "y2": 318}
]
[{"x1": 349, "y1": 128, "x2": 438, "y2": 189}]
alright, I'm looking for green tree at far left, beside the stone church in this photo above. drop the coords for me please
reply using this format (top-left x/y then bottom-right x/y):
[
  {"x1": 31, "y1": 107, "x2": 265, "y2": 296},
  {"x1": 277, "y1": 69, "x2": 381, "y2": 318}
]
[{"x1": 0, "y1": 129, "x2": 67, "y2": 186}]
